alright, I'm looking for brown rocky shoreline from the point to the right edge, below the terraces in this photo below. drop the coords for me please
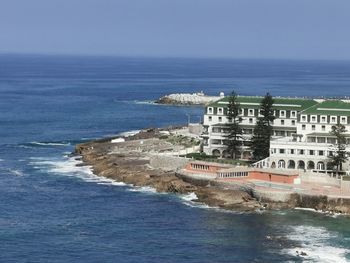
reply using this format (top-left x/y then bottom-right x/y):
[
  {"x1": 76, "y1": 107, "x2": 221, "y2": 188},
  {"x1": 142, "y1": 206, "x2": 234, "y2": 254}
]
[{"x1": 74, "y1": 128, "x2": 350, "y2": 214}]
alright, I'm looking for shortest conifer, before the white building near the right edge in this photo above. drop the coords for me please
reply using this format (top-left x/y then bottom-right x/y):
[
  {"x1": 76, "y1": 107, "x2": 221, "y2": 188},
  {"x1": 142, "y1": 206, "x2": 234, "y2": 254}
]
[{"x1": 329, "y1": 123, "x2": 348, "y2": 172}]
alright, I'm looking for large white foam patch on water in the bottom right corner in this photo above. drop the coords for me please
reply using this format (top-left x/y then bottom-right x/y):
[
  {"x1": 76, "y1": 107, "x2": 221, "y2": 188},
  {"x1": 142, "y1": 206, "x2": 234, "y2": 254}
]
[{"x1": 282, "y1": 225, "x2": 350, "y2": 263}]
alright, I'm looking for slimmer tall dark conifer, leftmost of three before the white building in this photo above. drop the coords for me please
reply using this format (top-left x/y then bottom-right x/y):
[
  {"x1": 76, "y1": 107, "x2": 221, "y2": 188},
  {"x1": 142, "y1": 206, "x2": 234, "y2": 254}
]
[{"x1": 226, "y1": 91, "x2": 242, "y2": 159}]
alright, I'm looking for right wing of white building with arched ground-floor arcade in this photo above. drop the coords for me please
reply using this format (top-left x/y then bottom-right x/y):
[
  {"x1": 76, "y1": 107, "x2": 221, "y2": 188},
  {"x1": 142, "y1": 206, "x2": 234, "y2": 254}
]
[{"x1": 268, "y1": 100, "x2": 350, "y2": 172}]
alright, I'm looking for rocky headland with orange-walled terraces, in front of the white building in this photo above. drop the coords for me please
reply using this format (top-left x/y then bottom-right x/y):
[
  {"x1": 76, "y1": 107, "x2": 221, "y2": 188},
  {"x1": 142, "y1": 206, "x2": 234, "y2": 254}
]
[{"x1": 75, "y1": 127, "x2": 350, "y2": 214}]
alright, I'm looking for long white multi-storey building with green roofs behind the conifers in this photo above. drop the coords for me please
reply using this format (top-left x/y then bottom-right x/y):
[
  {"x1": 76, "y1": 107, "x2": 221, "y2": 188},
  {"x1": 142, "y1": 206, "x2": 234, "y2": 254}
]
[{"x1": 202, "y1": 96, "x2": 350, "y2": 171}]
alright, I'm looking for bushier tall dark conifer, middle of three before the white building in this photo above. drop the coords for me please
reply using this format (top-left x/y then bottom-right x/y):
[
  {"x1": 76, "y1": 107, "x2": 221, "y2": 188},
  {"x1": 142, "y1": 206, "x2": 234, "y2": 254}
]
[{"x1": 251, "y1": 93, "x2": 275, "y2": 161}]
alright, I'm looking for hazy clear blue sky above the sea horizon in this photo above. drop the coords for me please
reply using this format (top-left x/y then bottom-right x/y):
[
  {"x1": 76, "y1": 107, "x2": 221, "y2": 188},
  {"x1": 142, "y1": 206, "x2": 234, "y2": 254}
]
[{"x1": 0, "y1": 0, "x2": 350, "y2": 59}]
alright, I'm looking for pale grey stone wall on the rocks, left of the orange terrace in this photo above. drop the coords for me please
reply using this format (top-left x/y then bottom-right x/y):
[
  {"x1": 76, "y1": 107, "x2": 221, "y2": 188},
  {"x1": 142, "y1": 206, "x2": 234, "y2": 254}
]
[{"x1": 150, "y1": 155, "x2": 189, "y2": 171}]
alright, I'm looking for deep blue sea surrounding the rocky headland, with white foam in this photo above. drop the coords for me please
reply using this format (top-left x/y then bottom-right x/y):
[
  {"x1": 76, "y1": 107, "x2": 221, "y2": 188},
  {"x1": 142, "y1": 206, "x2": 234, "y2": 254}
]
[{"x1": 0, "y1": 55, "x2": 350, "y2": 262}]
